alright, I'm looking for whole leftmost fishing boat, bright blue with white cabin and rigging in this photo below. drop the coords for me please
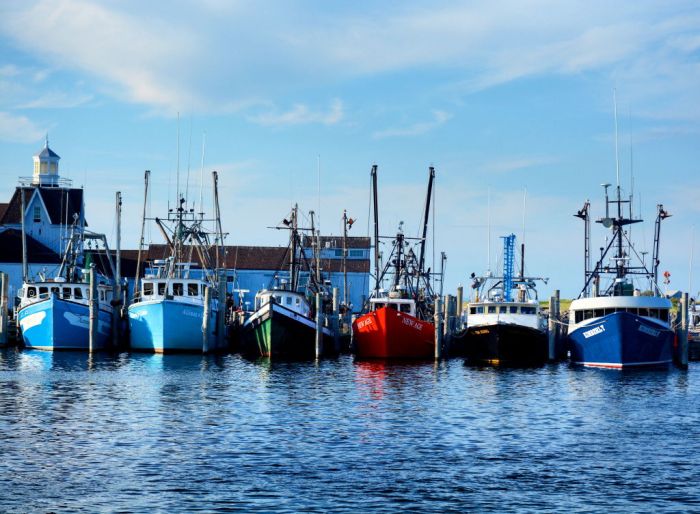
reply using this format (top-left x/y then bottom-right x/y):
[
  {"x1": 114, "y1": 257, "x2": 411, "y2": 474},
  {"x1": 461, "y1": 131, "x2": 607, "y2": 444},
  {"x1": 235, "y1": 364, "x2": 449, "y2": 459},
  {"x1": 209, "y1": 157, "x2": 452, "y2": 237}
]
[{"x1": 16, "y1": 224, "x2": 114, "y2": 350}]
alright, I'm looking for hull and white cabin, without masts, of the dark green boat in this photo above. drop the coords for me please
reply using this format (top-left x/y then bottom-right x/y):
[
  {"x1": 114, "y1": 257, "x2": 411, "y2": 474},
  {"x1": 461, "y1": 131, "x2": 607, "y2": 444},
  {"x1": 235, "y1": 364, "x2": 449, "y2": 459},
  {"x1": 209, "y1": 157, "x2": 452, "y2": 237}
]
[{"x1": 243, "y1": 289, "x2": 333, "y2": 359}]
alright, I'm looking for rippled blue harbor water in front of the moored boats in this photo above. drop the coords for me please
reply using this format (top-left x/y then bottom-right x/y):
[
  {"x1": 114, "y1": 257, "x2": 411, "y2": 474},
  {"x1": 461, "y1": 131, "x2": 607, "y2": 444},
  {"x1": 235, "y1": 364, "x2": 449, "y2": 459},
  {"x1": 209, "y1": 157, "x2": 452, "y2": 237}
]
[{"x1": 0, "y1": 350, "x2": 700, "y2": 512}]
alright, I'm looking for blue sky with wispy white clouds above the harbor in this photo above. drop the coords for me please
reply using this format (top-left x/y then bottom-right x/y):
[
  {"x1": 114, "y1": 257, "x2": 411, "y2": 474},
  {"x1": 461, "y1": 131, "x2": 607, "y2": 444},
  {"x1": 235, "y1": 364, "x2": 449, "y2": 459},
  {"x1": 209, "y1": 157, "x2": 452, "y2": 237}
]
[{"x1": 0, "y1": 0, "x2": 700, "y2": 298}]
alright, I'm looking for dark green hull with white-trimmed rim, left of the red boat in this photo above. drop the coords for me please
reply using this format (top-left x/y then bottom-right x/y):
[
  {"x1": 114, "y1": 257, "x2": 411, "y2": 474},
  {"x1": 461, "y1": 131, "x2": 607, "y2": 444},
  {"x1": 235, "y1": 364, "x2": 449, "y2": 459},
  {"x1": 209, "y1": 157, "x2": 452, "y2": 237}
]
[{"x1": 241, "y1": 303, "x2": 338, "y2": 359}]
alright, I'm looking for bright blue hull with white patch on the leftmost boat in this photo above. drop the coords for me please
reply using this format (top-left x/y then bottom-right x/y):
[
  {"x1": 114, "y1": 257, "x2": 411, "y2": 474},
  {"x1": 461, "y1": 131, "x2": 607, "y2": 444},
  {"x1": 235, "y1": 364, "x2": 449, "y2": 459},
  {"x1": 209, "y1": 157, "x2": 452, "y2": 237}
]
[{"x1": 17, "y1": 296, "x2": 112, "y2": 350}]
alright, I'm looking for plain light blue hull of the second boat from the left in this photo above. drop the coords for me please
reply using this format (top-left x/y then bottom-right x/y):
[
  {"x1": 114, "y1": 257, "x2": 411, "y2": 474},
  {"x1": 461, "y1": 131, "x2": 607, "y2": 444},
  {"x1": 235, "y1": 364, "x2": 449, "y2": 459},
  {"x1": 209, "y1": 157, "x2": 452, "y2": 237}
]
[{"x1": 129, "y1": 300, "x2": 219, "y2": 353}]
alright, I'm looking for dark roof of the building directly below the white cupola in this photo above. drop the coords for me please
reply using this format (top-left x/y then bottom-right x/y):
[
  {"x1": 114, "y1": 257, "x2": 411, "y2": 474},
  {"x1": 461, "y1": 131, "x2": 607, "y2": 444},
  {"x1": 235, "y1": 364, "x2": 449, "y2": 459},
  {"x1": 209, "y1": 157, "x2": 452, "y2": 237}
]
[{"x1": 0, "y1": 186, "x2": 87, "y2": 225}]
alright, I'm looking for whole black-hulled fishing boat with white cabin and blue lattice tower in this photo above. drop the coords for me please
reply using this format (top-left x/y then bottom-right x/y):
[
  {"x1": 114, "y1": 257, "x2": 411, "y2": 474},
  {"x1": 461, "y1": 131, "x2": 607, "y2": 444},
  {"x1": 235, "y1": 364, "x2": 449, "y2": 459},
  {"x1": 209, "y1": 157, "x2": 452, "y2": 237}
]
[{"x1": 456, "y1": 234, "x2": 548, "y2": 365}]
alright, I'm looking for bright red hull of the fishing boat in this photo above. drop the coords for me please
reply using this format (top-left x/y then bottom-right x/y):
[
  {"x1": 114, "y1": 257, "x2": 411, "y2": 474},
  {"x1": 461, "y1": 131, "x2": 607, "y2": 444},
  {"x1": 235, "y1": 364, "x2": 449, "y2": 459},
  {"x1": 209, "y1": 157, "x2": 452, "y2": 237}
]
[{"x1": 352, "y1": 307, "x2": 435, "y2": 359}]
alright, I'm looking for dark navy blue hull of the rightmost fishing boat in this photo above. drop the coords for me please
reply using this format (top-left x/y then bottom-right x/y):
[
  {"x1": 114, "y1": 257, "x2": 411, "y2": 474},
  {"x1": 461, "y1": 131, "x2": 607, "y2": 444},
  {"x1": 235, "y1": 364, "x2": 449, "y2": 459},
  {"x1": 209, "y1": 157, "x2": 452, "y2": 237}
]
[{"x1": 569, "y1": 312, "x2": 673, "y2": 368}]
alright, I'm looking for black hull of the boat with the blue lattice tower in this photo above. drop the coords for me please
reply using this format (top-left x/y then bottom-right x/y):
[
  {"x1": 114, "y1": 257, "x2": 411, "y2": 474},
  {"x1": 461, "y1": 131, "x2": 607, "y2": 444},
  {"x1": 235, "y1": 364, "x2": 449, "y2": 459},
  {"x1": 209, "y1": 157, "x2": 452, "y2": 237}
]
[{"x1": 464, "y1": 323, "x2": 549, "y2": 366}]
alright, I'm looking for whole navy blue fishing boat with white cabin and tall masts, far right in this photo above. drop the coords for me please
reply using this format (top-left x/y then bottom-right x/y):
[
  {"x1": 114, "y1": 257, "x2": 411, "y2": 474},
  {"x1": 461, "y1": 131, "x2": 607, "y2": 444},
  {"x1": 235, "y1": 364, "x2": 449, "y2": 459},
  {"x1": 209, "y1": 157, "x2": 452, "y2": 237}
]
[{"x1": 568, "y1": 185, "x2": 674, "y2": 369}]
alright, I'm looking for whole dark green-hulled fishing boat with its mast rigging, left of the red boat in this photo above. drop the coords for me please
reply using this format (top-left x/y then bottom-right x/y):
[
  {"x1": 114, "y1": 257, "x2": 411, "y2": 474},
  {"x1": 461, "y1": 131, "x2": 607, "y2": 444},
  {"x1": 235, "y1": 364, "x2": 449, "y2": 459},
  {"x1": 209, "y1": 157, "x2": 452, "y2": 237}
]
[{"x1": 241, "y1": 206, "x2": 338, "y2": 359}]
